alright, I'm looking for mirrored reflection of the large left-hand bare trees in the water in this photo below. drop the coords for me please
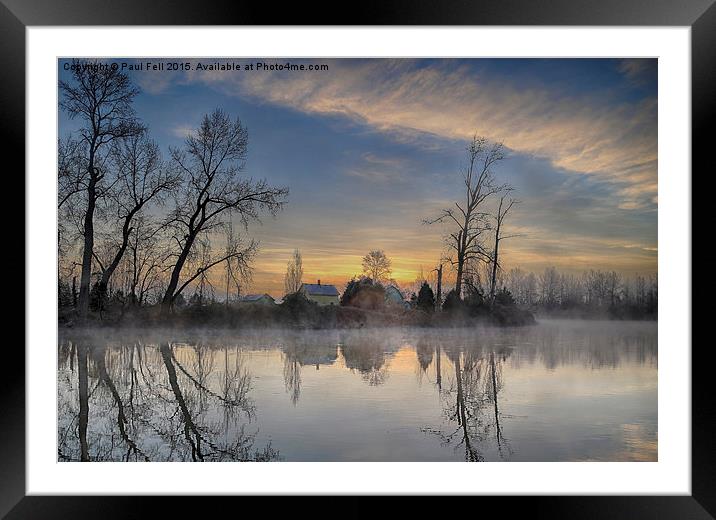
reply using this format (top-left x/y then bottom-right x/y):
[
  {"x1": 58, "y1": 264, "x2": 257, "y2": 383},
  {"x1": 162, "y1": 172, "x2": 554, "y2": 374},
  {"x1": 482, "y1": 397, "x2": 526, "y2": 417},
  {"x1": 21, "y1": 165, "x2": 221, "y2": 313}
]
[{"x1": 58, "y1": 341, "x2": 279, "y2": 461}]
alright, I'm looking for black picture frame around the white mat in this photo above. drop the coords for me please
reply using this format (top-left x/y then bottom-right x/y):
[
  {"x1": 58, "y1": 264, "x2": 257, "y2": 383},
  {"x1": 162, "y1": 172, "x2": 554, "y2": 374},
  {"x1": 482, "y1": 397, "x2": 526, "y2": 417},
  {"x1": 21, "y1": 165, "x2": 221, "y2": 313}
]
[{"x1": 0, "y1": 0, "x2": 716, "y2": 518}]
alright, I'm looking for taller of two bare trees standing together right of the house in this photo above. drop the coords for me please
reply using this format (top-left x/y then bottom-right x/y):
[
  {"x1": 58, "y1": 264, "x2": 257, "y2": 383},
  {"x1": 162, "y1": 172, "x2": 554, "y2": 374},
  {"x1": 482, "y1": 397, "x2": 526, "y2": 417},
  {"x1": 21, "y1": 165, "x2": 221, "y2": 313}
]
[{"x1": 424, "y1": 136, "x2": 505, "y2": 296}]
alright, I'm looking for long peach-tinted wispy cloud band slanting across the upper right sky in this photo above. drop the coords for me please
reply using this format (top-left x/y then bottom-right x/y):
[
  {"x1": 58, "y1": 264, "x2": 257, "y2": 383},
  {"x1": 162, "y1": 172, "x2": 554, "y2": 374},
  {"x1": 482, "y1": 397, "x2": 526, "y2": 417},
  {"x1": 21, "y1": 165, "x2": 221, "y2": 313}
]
[{"x1": 172, "y1": 60, "x2": 657, "y2": 208}]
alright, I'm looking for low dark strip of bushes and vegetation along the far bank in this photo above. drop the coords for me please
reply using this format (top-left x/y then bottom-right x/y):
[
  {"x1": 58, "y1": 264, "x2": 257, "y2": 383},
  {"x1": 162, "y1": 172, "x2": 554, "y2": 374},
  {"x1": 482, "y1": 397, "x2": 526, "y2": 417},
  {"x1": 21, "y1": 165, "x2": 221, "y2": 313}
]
[{"x1": 58, "y1": 272, "x2": 657, "y2": 330}]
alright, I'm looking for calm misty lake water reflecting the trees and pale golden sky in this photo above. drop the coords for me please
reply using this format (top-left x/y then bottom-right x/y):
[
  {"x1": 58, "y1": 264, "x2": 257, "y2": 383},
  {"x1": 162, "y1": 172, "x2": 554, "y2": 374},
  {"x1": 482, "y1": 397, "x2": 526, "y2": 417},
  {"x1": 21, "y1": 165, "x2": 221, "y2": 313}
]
[{"x1": 58, "y1": 320, "x2": 658, "y2": 461}]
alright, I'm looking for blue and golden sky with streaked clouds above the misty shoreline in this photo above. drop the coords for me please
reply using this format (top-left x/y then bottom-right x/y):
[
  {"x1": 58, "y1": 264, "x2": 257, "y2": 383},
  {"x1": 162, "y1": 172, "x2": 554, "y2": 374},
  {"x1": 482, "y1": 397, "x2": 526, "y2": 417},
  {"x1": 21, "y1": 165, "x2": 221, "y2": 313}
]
[{"x1": 59, "y1": 58, "x2": 658, "y2": 296}]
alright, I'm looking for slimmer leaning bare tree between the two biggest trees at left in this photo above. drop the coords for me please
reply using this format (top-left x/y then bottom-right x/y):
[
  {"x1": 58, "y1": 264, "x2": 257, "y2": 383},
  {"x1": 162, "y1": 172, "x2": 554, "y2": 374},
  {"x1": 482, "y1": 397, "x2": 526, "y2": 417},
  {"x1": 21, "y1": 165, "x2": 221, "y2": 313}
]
[{"x1": 98, "y1": 131, "x2": 177, "y2": 304}]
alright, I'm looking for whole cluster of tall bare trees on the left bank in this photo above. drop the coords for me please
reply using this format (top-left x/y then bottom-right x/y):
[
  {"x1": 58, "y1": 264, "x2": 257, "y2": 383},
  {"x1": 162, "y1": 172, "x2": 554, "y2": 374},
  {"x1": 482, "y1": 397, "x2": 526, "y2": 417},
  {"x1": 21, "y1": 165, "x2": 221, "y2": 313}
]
[{"x1": 58, "y1": 60, "x2": 288, "y2": 321}]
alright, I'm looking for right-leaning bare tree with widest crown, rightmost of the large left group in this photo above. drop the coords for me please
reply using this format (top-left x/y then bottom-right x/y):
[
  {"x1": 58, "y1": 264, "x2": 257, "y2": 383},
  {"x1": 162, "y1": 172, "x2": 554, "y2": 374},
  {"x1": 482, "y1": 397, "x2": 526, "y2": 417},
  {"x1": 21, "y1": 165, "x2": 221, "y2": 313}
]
[{"x1": 162, "y1": 109, "x2": 288, "y2": 313}]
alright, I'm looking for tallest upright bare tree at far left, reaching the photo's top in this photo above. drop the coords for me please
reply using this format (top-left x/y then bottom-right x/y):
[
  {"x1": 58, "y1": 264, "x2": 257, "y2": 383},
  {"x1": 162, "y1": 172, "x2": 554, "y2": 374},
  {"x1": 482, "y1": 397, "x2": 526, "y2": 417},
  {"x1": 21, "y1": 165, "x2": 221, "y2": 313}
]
[{"x1": 60, "y1": 60, "x2": 141, "y2": 320}]
